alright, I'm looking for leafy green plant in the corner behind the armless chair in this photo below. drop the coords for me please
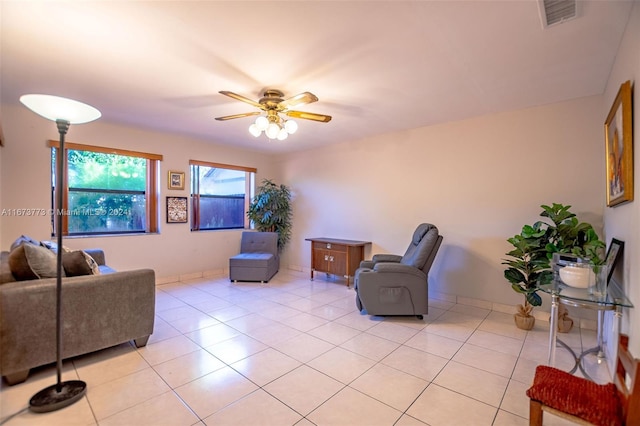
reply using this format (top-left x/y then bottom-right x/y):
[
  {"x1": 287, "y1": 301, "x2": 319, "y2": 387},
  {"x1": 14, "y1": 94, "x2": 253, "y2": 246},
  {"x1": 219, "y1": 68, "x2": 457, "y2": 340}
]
[{"x1": 247, "y1": 179, "x2": 292, "y2": 252}]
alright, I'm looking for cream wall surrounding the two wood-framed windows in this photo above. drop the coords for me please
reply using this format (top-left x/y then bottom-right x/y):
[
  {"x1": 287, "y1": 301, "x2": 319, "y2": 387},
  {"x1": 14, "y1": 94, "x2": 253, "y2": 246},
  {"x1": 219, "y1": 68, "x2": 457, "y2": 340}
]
[{"x1": 0, "y1": 105, "x2": 273, "y2": 281}]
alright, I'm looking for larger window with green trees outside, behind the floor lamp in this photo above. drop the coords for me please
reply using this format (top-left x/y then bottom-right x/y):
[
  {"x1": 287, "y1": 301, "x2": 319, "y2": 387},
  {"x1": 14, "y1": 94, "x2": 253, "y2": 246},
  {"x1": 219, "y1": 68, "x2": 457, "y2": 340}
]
[{"x1": 49, "y1": 141, "x2": 162, "y2": 235}]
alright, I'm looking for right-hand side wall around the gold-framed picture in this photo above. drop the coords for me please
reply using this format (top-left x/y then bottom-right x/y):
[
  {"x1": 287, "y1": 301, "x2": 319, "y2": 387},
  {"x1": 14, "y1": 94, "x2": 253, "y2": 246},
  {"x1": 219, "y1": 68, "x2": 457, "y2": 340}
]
[{"x1": 600, "y1": 2, "x2": 640, "y2": 356}]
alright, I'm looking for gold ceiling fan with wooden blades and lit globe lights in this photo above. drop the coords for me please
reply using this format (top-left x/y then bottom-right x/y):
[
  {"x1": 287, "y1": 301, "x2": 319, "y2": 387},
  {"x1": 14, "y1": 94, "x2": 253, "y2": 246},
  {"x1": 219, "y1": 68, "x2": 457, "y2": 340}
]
[{"x1": 216, "y1": 89, "x2": 331, "y2": 140}]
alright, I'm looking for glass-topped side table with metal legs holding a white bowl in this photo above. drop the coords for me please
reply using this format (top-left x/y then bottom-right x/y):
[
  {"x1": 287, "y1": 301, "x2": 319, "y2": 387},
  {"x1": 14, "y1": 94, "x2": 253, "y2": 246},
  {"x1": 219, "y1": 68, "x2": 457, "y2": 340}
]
[{"x1": 538, "y1": 280, "x2": 633, "y2": 379}]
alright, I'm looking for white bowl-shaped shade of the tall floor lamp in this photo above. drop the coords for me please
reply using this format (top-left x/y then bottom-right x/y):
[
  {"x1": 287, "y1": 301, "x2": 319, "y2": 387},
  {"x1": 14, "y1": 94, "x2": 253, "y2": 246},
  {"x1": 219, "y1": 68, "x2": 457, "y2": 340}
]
[{"x1": 20, "y1": 94, "x2": 102, "y2": 124}]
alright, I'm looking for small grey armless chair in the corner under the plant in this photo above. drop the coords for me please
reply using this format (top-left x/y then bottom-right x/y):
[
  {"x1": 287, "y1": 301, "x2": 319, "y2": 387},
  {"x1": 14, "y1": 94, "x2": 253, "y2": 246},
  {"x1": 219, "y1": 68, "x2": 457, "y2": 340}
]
[{"x1": 229, "y1": 231, "x2": 280, "y2": 283}]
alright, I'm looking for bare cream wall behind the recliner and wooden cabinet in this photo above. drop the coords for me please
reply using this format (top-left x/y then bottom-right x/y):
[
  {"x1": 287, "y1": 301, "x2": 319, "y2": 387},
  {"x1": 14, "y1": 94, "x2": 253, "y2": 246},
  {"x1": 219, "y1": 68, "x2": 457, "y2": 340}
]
[{"x1": 279, "y1": 96, "x2": 605, "y2": 309}]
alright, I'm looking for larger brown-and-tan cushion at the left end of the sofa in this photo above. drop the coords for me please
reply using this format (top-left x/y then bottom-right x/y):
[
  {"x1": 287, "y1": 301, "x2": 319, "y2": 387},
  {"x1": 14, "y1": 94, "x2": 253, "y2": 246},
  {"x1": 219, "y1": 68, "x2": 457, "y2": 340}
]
[{"x1": 9, "y1": 242, "x2": 64, "y2": 281}]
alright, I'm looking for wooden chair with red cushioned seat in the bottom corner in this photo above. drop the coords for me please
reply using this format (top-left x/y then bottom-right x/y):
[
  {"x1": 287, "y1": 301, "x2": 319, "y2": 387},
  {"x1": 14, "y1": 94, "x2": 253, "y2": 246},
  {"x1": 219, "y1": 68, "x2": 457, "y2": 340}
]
[{"x1": 527, "y1": 335, "x2": 640, "y2": 426}]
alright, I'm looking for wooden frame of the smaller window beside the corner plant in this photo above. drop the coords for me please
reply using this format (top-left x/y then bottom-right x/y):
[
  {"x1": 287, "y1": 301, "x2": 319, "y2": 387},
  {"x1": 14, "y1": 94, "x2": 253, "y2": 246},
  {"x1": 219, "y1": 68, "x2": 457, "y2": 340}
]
[{"x1": 189, "y1": 160, "x2": 258, "y2": 232}]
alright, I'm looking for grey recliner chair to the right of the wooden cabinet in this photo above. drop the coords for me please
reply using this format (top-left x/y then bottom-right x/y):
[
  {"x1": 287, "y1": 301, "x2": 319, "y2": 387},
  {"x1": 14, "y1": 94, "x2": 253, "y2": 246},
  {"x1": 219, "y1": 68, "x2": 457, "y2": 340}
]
[{"x1": 354, "y1": 223, "x2": 442, "y2": 319}]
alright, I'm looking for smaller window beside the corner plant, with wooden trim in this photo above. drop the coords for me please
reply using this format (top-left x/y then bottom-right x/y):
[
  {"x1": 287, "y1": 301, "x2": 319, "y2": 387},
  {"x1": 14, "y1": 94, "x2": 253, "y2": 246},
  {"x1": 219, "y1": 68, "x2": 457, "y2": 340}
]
[{"x1": 189, "y1": 160, "x2": 257, "y2": 231}]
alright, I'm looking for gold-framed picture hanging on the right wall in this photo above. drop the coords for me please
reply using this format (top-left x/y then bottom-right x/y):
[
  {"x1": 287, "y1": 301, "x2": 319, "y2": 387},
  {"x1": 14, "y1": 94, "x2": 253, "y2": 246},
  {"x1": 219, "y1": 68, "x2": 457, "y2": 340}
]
[{"x1": 604, "y1": 80, "x2": 633, "y2": 207}]
